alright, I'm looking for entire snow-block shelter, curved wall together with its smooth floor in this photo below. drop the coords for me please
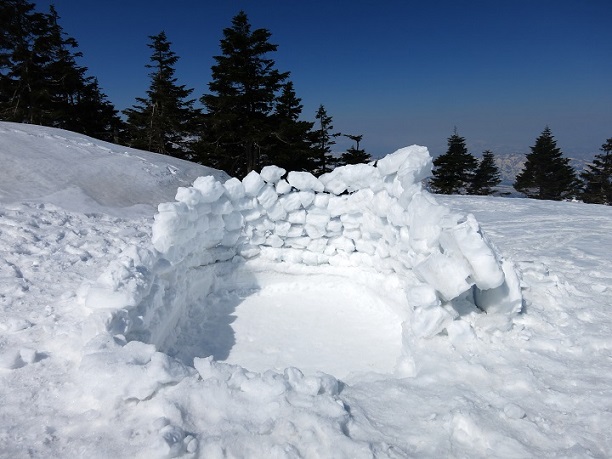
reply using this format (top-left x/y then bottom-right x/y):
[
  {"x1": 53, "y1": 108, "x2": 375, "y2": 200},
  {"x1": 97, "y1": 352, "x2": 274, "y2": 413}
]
[{"x1": 84, "y1": 145, "x2": 522, "y2": 398}]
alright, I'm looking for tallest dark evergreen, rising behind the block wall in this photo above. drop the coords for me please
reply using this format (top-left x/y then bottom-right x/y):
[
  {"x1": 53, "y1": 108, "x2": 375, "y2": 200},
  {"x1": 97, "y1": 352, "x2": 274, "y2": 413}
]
[{"x1": 199, "y1": 11, "x2": 289, "y2": 177}]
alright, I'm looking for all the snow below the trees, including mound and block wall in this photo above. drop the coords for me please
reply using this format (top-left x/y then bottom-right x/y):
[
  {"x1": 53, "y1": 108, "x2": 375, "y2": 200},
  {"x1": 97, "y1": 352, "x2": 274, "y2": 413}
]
[{"x1": 0, "y1": 123, "x2": 612, "y2": 458}]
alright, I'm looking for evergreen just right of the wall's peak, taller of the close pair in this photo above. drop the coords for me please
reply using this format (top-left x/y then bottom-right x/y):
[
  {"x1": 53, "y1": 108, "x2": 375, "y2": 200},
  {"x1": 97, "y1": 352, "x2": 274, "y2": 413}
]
[{"x1": 430, "y1": 128, "x2": 478, "y2": 194}]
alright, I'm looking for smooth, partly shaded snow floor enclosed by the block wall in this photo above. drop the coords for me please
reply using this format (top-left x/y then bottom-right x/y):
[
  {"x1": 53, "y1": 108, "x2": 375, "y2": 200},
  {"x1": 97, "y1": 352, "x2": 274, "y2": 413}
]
[{"x1": 167, "y1": 269, "x2": 402, "y2": 380}]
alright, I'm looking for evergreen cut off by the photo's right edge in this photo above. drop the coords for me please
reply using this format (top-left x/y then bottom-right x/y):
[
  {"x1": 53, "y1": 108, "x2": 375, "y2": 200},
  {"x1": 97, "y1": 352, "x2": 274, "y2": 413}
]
[{"x1": 580, "y1": 138, "x2": 612, "y2": 205}]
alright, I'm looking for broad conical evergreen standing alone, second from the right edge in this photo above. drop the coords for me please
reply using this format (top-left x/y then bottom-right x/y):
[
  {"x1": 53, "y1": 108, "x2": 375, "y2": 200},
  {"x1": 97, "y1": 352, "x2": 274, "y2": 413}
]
[{"x1": 514, "y1": 126, "x2": 578, "y2": 201}]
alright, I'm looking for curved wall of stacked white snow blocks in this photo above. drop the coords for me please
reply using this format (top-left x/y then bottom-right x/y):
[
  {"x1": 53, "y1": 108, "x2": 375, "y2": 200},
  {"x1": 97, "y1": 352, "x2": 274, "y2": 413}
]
[{"x1": 81, "y1": 146, "x2": 522, "y2": 354}]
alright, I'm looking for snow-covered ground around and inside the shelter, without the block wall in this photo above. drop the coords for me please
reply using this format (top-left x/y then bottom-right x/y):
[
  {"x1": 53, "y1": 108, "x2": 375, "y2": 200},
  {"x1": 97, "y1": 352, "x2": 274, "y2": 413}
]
[{"x1": 0, "y1": 123, "x2": 612, "y2": 458}]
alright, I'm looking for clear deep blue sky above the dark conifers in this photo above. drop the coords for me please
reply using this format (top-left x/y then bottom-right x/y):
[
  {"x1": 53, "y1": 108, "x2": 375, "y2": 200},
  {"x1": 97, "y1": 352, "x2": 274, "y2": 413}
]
[{"x1": 33, "y1": 0, "x2": 612, "y2": 157}]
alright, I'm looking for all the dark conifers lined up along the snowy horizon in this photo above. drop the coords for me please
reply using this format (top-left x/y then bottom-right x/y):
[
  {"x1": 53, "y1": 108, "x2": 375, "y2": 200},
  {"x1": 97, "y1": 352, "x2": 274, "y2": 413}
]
[{"x1": 0, "y1": 0, "x2": 612, "y2": 205}]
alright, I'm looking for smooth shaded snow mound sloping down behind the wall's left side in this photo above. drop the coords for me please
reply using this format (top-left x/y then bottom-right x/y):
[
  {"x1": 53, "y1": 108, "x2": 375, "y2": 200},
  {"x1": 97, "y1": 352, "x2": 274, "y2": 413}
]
[{"x1": 0, "y1": 122, "x2": 227, "y2": 217}]
